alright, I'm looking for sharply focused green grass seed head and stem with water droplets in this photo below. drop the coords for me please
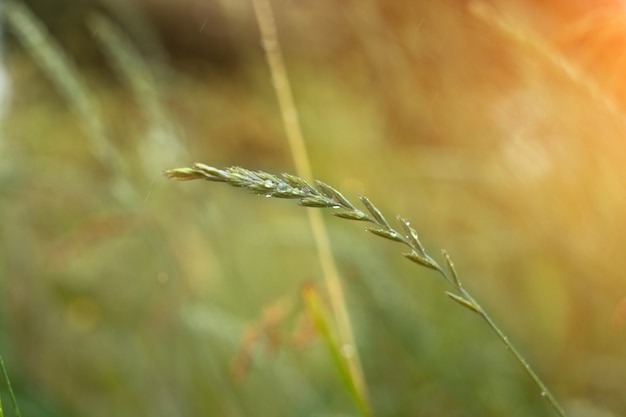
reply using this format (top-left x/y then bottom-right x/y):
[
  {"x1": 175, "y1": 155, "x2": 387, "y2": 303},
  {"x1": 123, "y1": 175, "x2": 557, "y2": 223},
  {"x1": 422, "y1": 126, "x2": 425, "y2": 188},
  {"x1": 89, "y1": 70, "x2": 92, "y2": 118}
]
[{"x1": 164, "y1": 163, "x2": 565, "y2": 417}]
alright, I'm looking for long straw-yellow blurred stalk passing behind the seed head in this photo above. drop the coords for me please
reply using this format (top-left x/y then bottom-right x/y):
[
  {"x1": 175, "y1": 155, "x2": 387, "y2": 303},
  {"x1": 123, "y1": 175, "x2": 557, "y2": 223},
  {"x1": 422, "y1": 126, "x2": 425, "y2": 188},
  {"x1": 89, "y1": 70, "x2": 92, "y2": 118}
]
[{"x1": 247, "y1": 0, "x2": 371, "y2": 416}]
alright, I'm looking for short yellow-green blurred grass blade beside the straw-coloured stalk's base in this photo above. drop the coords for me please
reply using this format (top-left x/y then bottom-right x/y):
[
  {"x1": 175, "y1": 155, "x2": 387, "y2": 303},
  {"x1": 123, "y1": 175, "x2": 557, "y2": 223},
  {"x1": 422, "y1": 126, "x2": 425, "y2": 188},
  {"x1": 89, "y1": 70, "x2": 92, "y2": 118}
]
[{"x1": 302, "y1": 283, "x2": 372, "y2": 417}]
